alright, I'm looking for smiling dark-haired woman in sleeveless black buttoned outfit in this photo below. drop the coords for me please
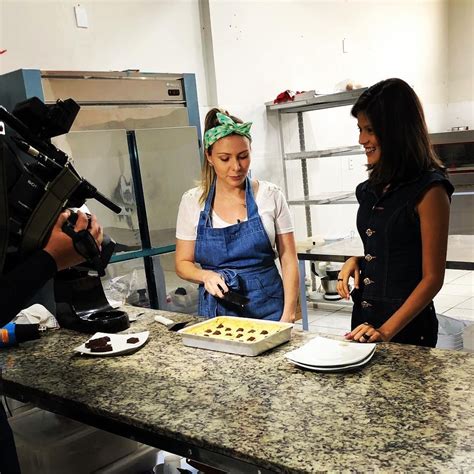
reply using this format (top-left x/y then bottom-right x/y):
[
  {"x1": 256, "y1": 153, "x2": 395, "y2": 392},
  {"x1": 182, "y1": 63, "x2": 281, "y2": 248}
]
[{"x1": 337, "y1": 79, "x2": 454, "y2": 347}]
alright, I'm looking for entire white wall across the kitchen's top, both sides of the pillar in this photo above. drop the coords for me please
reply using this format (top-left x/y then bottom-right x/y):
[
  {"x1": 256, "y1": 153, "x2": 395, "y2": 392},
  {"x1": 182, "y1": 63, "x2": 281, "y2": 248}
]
[{"x1": 0, "y1": 0, "x2": 474, "y2": 243}]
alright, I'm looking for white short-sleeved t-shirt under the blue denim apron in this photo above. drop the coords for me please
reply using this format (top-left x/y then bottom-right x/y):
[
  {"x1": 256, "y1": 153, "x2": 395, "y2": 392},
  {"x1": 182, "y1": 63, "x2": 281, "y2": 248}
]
[{"x1": 176, "y1": 181, "x2": 294, "y2": 250}]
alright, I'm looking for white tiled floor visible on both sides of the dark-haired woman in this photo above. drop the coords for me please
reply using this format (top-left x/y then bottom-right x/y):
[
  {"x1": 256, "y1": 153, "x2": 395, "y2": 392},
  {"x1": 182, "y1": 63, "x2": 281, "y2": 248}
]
[{"x1": 296, "y1": 270, "x2": 474, "y2": 350}]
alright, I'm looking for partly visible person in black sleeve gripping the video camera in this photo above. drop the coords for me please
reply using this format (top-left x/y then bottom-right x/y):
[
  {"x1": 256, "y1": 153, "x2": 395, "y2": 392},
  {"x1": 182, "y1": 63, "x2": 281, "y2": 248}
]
[{"x1": 0, "y1": 210, "x2": 103, "y2": 474}]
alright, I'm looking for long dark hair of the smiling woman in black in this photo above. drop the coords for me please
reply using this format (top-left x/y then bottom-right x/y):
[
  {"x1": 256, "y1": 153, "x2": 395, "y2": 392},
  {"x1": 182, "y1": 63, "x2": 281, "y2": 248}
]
[{"x1": 351, "y1": 78, "x2": 444, "y2": 186}]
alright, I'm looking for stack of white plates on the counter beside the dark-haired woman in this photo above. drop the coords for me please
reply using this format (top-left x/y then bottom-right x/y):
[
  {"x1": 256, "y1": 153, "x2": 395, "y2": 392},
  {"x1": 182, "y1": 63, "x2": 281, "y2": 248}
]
[{"x1": 285, "y1": 336, "x2": 376, "y2": 372}]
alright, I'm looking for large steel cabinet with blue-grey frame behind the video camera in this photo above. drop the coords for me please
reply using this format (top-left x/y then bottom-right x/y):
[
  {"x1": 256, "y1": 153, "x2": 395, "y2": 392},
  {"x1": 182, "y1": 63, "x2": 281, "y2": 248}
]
[{"x1": 0, "y1": 69, "x2": 202, "y2": 309}]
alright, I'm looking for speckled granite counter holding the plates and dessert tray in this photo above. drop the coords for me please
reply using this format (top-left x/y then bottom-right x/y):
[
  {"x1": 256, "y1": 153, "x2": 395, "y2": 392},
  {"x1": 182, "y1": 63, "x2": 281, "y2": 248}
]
[{"x1": 0, "y1": 307, "x2": 474, "y2": 472}]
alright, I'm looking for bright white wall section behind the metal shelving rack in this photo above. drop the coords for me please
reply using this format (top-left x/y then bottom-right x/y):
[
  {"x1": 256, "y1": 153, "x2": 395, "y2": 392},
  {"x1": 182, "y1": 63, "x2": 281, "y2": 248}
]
[{"x1": 211, "y1": 0, "x2": 448, "y2": 238}]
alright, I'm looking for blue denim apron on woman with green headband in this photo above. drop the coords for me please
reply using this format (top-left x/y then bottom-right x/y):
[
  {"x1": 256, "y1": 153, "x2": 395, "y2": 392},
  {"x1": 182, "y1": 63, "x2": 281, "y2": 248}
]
[{"x1": 194, "y1": 178, "x2": 283, "y2": 321}]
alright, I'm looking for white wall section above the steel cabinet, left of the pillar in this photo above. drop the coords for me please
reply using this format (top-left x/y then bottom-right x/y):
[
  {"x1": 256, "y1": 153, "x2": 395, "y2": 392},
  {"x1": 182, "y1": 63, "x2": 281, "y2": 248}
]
[{"x1": 0, "y1": 0, "x2": 207, "y2": 103}]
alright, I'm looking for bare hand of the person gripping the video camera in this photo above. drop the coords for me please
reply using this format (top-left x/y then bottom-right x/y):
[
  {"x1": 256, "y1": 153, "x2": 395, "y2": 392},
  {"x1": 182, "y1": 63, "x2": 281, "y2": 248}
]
[{"x1": 44, "y1": 211, "x2": 104, "y2": 271}]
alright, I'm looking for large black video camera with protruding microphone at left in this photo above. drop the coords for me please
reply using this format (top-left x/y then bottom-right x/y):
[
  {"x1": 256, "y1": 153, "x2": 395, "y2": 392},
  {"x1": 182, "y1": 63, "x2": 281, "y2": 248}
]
[{"x1": 0, "y1": 97, "x2": 121, "y2": 276}]
